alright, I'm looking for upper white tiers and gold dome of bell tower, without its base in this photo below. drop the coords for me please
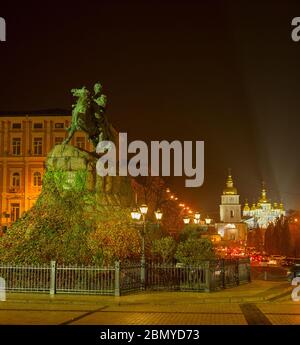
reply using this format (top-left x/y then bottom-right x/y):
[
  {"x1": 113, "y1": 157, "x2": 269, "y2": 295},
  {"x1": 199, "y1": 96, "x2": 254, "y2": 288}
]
[{"x1": 220, "y1": 169, "x2": 241, "y2": 223}]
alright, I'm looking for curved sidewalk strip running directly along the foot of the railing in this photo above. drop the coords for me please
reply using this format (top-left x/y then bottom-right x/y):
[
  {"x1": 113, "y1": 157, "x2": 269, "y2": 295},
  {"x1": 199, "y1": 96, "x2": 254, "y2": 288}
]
[{"x1": 0, "y1": 280, "x2": 292, "y2": 308}]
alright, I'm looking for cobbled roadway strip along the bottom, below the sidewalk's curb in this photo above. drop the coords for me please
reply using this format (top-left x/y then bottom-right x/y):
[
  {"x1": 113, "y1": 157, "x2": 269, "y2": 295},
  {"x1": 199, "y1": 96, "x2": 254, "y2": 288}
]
[{"x1": 0, "y1": 302, "x2": 300, "y2": 325}]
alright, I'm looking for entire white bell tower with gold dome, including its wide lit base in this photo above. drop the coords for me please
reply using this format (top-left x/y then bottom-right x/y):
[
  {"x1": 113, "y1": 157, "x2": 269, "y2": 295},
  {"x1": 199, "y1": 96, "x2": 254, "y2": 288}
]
[{"x1": 215, "y1": 172, "x2": 247, "y2": 245}]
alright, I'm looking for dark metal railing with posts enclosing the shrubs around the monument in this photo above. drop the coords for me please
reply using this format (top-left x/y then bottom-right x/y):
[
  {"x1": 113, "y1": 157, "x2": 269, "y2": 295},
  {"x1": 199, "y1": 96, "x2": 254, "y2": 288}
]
[{"x1": 0, "y1": 259, "x2": 250, "y2": 296}]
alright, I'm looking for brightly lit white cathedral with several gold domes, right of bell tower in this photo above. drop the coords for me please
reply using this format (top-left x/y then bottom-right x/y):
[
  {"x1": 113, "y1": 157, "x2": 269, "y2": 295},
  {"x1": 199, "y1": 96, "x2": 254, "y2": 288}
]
[{"x1": 243, "y1": 184, "x2": 285, "y2": 229}]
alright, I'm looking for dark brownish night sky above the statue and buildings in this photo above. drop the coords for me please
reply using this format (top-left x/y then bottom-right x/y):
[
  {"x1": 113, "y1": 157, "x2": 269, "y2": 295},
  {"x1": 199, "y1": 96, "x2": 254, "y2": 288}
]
[{"x1": 0, "y1": 0, "x2": 300, "y2": 213}]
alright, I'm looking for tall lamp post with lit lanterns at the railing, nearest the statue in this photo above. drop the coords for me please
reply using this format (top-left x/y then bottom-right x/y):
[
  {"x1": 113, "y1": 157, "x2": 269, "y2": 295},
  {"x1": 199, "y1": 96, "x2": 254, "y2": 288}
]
[{"x1": 131, "y1": 204, "x2": 163, "y2": 288}]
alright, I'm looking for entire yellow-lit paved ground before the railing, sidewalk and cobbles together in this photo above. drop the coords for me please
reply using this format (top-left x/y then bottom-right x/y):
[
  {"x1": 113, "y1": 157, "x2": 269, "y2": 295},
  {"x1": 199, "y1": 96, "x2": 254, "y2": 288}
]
[{"x1": 0, "y1": 284, "x2": 300, "y2": 325}]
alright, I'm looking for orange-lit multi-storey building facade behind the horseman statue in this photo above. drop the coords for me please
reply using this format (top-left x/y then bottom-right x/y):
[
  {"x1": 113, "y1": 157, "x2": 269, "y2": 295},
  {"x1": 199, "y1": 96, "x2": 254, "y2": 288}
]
[{"x1": 0, "y1": 110, "x2": 93, "y2": 231}]
